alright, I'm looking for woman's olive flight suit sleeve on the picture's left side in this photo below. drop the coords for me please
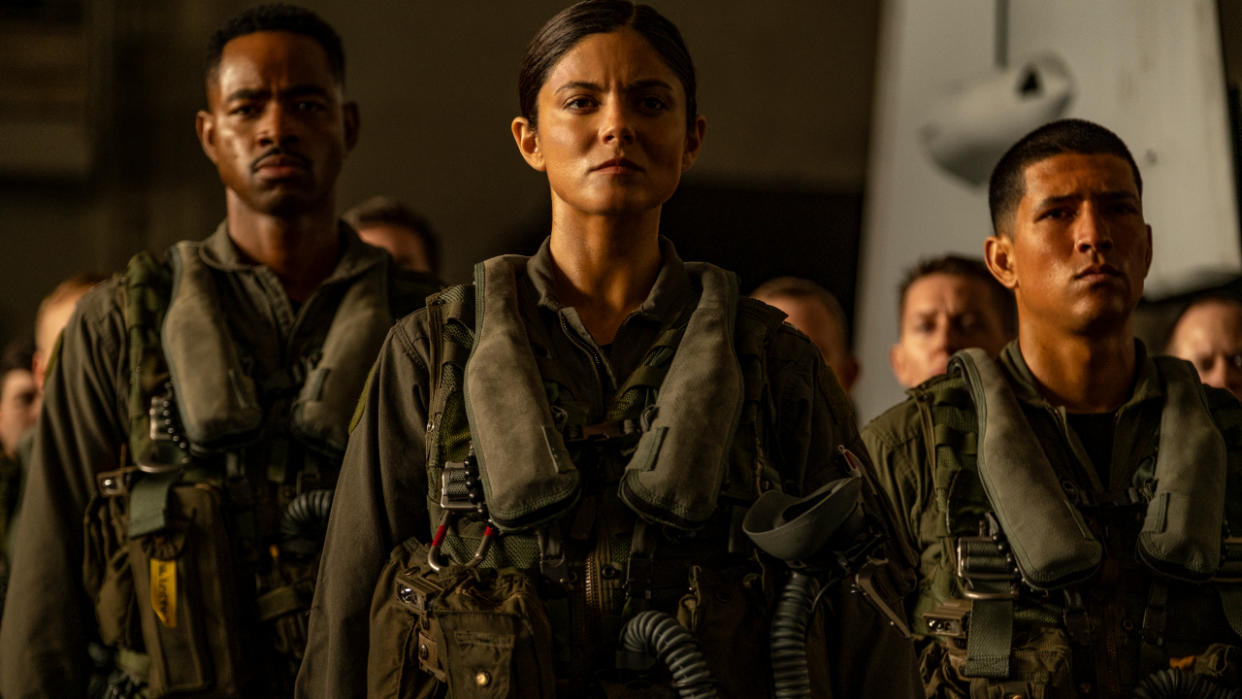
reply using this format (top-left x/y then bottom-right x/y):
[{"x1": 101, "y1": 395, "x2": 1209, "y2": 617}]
[{"x1": 296, "y1": 312, "x2": 430, "y2": 698}]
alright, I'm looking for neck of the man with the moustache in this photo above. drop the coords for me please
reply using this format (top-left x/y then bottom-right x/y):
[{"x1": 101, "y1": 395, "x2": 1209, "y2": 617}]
[{"x1": 227, "y1": 191, "x2": 340, "y2": 303}]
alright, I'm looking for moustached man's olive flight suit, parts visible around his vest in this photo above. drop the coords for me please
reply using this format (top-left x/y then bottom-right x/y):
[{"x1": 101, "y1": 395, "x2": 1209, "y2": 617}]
[{"x1": 0, "y1": 223, "x2": 437, "y2": 699}]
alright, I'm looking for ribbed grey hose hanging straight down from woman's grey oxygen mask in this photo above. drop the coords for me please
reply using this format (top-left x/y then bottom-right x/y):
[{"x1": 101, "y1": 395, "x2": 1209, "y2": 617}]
[{"x1": 771, "y1": 571, "x2": 818, "y2": 699}]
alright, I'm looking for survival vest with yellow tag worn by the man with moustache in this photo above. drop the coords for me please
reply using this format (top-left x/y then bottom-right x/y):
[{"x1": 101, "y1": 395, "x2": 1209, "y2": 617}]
[{"x1": 84, "y1": 242, "x2": 433, "y2": 697}]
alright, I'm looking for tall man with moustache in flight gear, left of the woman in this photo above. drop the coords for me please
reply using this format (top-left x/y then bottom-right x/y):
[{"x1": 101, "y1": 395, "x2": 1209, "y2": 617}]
[{"x1": 0, "y1": 5, "x2": 433, "y2": 698}]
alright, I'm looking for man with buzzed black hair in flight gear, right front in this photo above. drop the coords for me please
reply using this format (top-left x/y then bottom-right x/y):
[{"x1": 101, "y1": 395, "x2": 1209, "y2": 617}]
[{"x1": 863, "y1": 120, "x2": 1242, "y2": 697}]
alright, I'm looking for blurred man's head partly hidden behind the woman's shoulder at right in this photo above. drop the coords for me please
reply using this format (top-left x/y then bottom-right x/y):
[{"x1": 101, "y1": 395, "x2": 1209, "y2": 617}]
[{"x1": 750, "y1": 277, "x2": 858, "y2": 395}]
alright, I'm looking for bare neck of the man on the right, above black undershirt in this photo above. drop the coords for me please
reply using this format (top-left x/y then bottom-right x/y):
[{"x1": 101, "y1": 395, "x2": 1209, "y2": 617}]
[{"x1": 1018, "y1": 319, "x2": 1136, "y2": 412}]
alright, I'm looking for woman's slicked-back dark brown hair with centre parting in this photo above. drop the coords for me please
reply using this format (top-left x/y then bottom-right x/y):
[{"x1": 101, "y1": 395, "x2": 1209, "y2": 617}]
[{"x1": 518, "y1": 0, "x2": 698, "y2": 129}]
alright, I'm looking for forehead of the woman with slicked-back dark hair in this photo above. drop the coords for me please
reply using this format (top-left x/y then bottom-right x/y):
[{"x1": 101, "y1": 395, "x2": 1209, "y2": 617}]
[{"x1": 540, "y1": 27, "x2": 682, "y2": 92}]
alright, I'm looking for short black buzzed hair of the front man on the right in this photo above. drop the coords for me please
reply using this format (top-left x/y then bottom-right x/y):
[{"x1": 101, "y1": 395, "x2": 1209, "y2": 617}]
[{"x1": 987, "y1": 119, "x2": 1143, "y2": 236}]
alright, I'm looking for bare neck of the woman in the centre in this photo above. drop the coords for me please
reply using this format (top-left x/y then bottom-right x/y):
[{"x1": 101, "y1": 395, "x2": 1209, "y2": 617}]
[{"x1": 550, "y1": 205, "x2": 661, "y2": 345}]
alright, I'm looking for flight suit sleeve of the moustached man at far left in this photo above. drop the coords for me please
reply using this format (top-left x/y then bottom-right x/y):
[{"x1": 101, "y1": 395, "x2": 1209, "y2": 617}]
[{"x1": 0, "y1": 282, "x2": 128, "y2": 699}]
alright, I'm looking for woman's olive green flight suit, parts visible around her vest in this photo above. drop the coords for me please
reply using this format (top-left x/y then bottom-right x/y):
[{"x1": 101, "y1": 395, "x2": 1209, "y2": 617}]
[{"x1": 297, "y1": 238, "x2": 917, "y2": 698}]
